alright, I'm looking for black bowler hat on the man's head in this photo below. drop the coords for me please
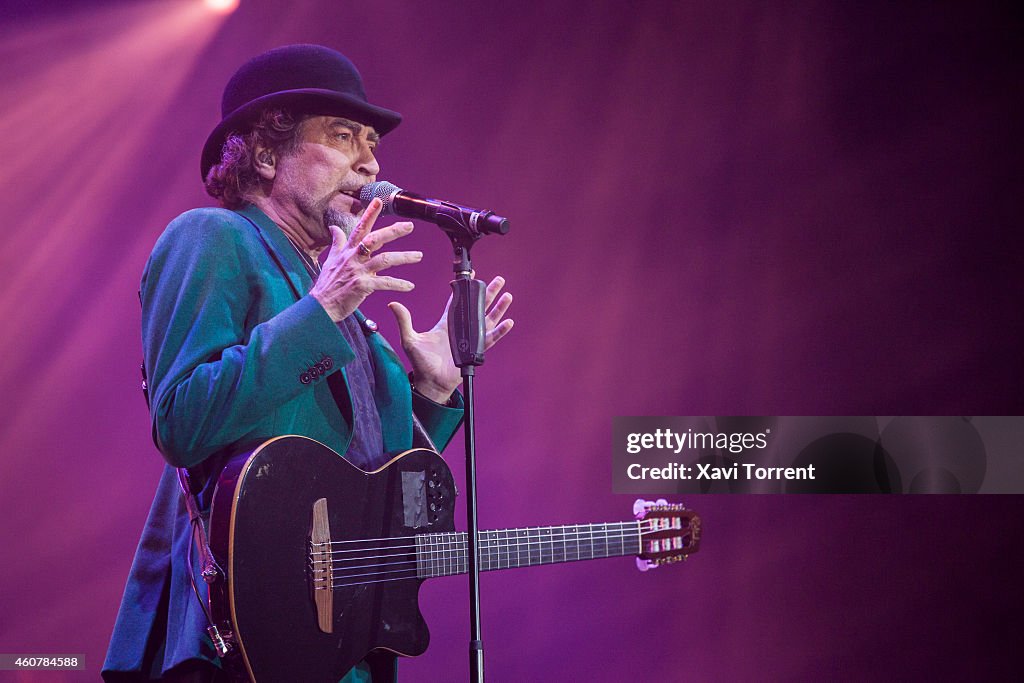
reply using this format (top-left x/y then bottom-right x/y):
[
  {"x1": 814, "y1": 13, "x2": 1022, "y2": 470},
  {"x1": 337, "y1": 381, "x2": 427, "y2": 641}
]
[{"x1": 201, "y1": 45, "x2": 401, "y2": 179}]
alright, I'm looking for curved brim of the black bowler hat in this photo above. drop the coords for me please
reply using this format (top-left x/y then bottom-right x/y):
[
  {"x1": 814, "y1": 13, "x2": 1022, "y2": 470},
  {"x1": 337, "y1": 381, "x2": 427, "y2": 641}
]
[{"x1": 200, "y1": 88, "x2": 401, "y2": 180}]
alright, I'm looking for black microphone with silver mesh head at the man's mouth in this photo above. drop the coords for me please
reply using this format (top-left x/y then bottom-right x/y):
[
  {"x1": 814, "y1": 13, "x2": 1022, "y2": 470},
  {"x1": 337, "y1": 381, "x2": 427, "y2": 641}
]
[{"x1": 359, "y1": 180, "x2": 509, "y2": 238}]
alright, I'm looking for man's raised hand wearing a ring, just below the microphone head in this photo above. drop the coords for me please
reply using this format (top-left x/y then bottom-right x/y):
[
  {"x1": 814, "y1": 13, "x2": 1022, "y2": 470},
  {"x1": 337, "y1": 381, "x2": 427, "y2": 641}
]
[{"x1": 309, "y1": 199, "x2": 423, "y2": 323}]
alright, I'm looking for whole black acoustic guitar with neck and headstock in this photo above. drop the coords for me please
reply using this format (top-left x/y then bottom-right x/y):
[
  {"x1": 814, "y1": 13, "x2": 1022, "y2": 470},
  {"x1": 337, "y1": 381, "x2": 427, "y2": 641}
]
[{"x1": 210, "y1": 436, "x2": 700, "y2": 683}]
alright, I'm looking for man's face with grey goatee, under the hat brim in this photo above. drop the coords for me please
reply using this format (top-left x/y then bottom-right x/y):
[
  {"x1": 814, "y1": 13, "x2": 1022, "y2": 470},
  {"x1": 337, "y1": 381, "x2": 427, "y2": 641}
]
[{"x1": 273, "y1": 116, "x2": 380, "y2": 245}]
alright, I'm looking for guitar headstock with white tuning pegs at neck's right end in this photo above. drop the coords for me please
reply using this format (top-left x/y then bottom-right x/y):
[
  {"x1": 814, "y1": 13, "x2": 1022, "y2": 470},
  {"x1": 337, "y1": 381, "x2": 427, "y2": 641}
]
[{"x1": 633, "y1": 498, "x2": 700, "y2": 571}]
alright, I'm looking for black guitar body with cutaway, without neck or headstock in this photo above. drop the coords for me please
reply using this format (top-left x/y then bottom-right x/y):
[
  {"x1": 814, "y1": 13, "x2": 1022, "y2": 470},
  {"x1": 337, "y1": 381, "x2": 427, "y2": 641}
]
[{"x1": 210, "y1": 436, "x2": 456, "y2": 683}]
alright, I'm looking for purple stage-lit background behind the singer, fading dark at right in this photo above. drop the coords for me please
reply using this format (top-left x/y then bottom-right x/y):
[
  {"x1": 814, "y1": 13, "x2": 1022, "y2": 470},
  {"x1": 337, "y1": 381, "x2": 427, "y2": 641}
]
[{"x1": 0, "y1": 0, "x2": 1024, "y2": 681}]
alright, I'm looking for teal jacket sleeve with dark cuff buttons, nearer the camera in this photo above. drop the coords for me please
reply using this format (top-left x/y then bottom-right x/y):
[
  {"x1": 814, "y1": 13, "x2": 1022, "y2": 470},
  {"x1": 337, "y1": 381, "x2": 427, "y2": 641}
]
[{"x1": 140, "y1": 209, "x2": 354, "y2": 467}]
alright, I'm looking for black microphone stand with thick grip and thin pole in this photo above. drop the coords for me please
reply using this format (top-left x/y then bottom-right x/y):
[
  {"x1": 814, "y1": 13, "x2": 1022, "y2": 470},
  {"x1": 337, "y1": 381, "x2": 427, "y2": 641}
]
[{"x1": 435, "y1": 202, "x2": 509, "y2": 683}]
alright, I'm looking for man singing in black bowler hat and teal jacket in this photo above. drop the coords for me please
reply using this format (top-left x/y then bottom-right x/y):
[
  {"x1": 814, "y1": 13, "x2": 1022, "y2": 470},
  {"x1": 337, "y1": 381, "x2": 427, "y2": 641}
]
[{"x1": 103, "y1": 45, "x2": 512, "y2": 681}]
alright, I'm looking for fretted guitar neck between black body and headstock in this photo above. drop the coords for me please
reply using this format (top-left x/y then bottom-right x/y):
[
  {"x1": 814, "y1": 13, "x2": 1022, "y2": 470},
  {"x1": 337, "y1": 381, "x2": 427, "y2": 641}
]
[{"x1": 416, "y1": 521, "x2": 641, "y2": 579}]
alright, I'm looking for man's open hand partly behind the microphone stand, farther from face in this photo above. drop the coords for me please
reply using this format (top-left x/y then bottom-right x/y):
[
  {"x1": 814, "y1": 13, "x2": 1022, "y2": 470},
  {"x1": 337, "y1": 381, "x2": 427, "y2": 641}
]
[{"x1": 388, "y1": 276, "x2": 520, "y2": 403}]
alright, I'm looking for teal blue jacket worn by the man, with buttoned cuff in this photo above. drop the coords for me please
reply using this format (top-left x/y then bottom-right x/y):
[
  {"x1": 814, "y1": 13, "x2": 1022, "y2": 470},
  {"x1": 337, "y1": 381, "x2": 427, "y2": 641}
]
[{"x1": 103, "y1": 206, "x2": 463, "y2": 680}]
